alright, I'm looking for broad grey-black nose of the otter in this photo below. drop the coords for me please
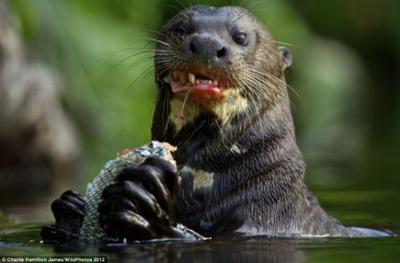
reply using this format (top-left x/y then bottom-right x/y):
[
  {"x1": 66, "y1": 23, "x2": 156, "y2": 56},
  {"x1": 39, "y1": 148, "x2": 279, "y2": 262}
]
[{"x1": 190, "y1": 34, "x2": 227, "y2": 60}]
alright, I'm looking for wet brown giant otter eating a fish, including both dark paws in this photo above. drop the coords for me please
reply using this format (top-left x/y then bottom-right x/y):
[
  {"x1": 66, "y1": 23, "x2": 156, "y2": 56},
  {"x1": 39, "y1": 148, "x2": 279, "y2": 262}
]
[{"x1": 42, "y1": 6, "x2": 388, "y2": 241}]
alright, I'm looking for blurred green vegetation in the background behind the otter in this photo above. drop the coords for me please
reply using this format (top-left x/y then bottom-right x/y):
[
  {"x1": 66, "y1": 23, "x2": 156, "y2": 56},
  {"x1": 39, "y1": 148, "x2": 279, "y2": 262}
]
[{"x1": 10, "y1": 0, "x2": 400, "y2": 194}]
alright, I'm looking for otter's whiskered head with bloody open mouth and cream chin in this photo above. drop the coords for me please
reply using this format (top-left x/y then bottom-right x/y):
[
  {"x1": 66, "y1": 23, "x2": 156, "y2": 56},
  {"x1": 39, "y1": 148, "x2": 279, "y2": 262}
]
[{"x1": 155, "y1": 6, "x2": 291, "y2": 134}]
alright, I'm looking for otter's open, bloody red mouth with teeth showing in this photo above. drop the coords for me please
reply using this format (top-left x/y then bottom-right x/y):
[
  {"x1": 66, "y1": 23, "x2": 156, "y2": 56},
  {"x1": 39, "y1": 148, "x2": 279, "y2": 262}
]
[{"x1": 164, "y1": 71, "x2": 227, "y2": 104}]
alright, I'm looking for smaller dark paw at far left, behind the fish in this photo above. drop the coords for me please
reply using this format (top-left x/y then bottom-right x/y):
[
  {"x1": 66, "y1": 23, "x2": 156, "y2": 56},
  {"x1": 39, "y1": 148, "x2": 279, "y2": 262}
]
[{"x1": 41, "y1": 190, "x2": 85, "y2": 243}]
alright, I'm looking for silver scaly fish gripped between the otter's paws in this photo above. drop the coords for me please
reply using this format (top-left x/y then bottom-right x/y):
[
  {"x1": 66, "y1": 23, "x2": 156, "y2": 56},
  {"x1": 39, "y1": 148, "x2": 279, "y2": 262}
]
[{"x1": 80, "y1": 141, "x2": 173, "y2": 241}]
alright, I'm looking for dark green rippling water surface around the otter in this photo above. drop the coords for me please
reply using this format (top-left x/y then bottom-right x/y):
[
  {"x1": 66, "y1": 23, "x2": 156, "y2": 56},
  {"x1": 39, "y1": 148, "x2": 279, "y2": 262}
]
[{"x1": 0, "y1": 191, "x2": 400, "y2": 263}]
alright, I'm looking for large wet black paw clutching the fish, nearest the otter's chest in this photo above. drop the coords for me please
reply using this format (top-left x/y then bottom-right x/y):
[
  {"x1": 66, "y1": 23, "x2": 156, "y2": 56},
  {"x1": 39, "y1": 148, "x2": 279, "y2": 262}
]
[{"x1": 99, "y1": 157, "x2": 179, "y2": 241}]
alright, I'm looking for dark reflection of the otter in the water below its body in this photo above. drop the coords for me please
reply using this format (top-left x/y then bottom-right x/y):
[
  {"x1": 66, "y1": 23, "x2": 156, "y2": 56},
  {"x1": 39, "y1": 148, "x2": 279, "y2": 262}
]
[{"x1": 101, "y1": 238, "x2": 305, "y2": 262}]
